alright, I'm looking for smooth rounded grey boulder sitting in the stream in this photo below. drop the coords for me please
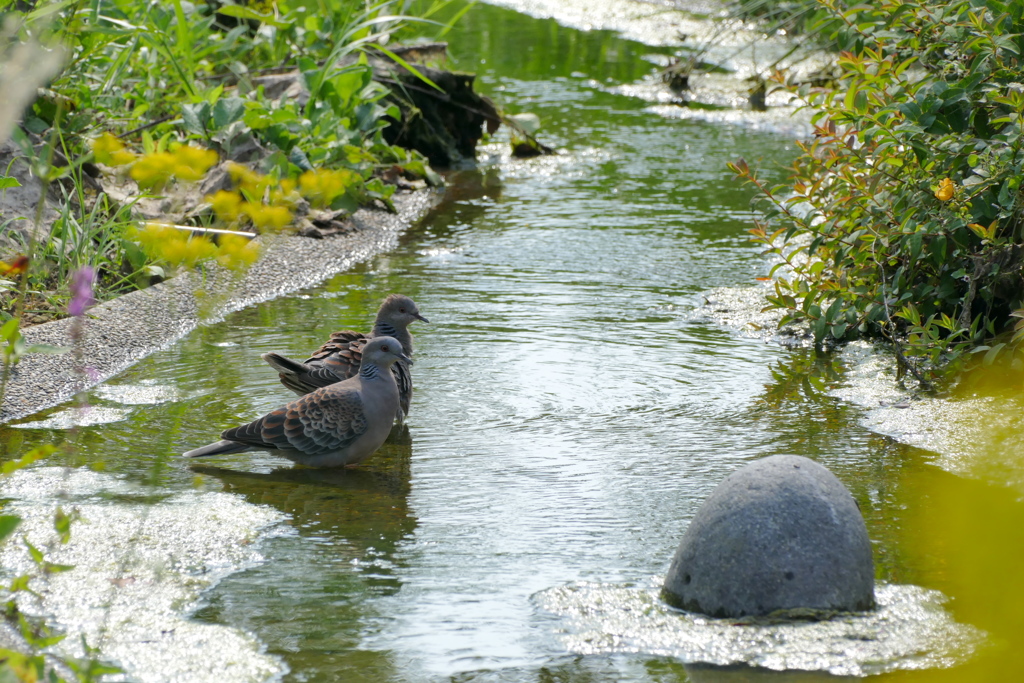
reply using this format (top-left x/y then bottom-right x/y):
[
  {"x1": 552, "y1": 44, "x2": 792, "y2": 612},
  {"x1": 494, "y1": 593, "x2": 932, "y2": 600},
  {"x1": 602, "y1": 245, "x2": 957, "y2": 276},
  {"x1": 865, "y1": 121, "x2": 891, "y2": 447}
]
[{"x1": 662, "y1": 456, "x2": 874, "y2": 617}]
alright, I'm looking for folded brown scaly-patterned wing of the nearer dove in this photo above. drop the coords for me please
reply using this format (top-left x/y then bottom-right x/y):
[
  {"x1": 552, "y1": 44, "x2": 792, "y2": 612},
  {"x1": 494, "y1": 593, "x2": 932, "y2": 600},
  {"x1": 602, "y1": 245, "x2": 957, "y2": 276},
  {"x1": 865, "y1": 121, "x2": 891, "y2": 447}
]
[{"x1": 221, "y1": 385, "x2": 368, "y2": 455}]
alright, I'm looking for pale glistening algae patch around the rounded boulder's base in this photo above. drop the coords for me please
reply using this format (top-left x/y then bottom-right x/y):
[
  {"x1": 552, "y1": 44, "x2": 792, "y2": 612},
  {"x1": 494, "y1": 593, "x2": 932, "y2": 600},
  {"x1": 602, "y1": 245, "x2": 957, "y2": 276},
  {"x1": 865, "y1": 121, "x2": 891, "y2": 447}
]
[{"x1": 534, "y1": 578, "x2": 984, "y2": 676}]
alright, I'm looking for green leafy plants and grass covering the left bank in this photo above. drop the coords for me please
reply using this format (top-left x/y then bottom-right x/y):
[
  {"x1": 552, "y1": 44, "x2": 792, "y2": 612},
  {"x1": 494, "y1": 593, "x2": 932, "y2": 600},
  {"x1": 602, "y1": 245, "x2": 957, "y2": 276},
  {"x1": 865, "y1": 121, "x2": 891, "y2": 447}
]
[{"x1": 0, "y1": 0, "x2": 444, "y2": 324}]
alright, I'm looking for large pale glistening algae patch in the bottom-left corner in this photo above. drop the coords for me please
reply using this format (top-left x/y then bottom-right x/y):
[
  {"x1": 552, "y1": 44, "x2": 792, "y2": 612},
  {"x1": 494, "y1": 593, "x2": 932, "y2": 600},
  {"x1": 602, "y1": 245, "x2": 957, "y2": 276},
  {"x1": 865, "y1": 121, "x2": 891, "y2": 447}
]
[{"x1": 0, "y1": 467, "x2": 285, "y2": 683}]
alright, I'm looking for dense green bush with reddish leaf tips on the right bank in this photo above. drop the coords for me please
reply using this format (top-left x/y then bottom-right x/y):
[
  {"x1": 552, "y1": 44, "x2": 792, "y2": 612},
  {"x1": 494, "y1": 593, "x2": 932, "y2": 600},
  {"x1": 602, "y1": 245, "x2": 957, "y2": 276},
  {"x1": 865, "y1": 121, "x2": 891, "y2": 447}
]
[{"x1": 731, "y1": 0, "x2": 1024, "y2": 384}]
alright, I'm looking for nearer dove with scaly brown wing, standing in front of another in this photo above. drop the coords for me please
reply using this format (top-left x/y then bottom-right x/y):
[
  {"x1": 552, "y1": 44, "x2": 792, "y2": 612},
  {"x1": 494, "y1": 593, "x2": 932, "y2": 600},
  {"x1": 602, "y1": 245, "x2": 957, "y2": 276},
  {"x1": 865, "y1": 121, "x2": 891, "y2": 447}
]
[{"x1": 181, "y1": 337, "x2": 413, "y2": 467}]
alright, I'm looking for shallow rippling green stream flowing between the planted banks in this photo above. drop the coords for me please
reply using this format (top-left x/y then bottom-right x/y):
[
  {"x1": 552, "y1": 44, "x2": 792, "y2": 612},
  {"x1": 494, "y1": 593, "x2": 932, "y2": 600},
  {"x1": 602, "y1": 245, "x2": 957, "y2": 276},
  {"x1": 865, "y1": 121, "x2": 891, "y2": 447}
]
[{"x1": 0, "y1": 5, "x2": 995, "y2": 681}]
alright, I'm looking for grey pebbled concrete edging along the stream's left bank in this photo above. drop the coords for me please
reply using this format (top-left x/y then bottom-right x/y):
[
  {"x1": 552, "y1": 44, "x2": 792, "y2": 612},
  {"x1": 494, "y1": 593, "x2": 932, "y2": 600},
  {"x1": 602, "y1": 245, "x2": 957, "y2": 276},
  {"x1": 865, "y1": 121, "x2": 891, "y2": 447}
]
[{"x1": 0, "y1": 190, "x2": 436, "y2": 422}]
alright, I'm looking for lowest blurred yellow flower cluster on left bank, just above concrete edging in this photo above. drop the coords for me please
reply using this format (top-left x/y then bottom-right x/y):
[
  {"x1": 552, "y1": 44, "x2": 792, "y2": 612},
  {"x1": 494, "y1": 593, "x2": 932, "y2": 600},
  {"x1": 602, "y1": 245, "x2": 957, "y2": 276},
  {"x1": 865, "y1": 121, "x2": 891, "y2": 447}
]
[{"x1": 135, "y1": 222, "x2": 259, "y2": 270}]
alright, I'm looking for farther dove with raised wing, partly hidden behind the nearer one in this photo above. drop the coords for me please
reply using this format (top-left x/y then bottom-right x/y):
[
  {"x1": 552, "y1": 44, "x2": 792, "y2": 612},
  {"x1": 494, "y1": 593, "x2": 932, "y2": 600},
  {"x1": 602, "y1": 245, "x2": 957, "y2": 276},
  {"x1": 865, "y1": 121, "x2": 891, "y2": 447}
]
[{"x1": 262, "y1": 294, "x2": 430, "y2": 424}]
